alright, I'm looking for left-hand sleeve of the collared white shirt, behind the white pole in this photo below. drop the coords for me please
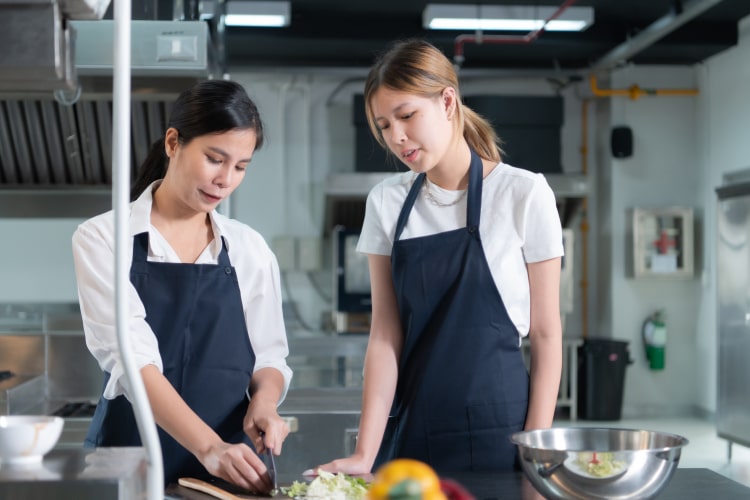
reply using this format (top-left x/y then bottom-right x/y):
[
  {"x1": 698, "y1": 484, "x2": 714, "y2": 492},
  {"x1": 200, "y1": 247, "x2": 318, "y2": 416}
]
[{"x1": 73, "y1": 224, "x2": 163, "y2": 399}]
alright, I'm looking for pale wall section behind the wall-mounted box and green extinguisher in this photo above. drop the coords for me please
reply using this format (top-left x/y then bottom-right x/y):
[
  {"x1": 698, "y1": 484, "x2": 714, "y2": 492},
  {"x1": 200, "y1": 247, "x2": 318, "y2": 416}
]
[{"x1": 598, "y1": 67, "x2": 703, "y2": 415}]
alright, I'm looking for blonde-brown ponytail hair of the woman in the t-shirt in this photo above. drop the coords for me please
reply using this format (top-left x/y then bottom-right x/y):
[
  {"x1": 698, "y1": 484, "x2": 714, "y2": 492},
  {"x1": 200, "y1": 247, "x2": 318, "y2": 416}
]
[{"x1": 364, "y1": 39, "x2": 502, "y2": 161}]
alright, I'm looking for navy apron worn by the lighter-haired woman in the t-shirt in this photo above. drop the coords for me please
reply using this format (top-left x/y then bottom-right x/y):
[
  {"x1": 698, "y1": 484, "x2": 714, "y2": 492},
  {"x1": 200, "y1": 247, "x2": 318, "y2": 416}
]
[{"x1": 375, "y1": 151, "x2": 529, "y2": 473}]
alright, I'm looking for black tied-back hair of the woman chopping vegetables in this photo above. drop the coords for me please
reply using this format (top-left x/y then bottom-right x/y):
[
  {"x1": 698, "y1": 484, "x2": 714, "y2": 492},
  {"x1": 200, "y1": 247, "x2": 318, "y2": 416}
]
[{"x1": 130, "y1": 80, "x2": 263, "y2": 201}]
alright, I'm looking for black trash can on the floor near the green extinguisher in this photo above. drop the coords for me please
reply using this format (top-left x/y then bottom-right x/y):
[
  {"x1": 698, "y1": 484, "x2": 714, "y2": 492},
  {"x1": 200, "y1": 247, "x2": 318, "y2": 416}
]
[{"x1": 578, "y1": 338, "x2": 631, "y2": 420}]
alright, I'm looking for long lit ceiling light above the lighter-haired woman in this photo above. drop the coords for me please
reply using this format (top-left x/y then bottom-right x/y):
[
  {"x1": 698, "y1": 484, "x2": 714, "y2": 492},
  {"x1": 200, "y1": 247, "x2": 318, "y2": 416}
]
[{"x1": 422, "y1": 4, "x2": 594, "y2": 31}]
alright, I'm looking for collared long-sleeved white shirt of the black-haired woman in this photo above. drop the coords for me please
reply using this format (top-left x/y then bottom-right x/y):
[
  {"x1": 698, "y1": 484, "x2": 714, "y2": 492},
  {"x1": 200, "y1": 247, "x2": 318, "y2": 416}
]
[{"x1": 73, "y1": 181, "x2": 292, "y2": 403}]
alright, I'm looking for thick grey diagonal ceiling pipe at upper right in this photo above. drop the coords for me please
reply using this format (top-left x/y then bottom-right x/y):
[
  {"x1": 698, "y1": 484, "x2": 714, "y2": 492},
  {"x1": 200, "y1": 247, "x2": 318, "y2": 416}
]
[{"x1": 591, "y1": 0, "x2": 722, "y2": 71}]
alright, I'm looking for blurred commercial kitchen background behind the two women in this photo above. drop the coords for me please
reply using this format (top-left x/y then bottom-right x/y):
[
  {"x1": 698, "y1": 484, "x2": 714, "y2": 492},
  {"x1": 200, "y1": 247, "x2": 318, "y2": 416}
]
[{"x1": 0, "y1": 0, "x2": 750, "y2": 499}]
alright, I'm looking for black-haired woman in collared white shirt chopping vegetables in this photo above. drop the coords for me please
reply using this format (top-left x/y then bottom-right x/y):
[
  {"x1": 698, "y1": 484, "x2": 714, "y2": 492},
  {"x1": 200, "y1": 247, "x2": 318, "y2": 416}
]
[{"x1": 73, "y1": 80, "x2": 292, "y2": 492}]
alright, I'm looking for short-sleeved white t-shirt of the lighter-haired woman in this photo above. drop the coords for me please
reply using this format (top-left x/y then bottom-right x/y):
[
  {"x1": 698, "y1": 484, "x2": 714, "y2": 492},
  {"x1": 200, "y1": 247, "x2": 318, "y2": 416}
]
[{"x1": 357, "y1": 163, "x2": 563, "y2": 337}]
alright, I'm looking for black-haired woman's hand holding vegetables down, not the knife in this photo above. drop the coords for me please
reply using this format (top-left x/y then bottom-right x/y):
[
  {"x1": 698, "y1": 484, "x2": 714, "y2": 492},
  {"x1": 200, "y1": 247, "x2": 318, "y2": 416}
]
[{"x1": 197, "y1": 441, "x2": 273, "y2": 493}]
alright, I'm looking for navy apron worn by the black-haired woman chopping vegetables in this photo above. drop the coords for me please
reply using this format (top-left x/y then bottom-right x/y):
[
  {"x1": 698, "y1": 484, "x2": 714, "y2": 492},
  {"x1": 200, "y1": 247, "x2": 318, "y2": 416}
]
[{"x1": 85, "y1": 233, "x2": 255, "y2": 484}]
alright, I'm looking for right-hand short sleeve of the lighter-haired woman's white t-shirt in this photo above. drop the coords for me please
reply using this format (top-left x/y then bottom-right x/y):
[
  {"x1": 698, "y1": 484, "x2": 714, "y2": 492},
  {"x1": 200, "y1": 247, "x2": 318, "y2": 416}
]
[{"x1": 523, "y1": 174, "x2": 564, "y2": 263}]
